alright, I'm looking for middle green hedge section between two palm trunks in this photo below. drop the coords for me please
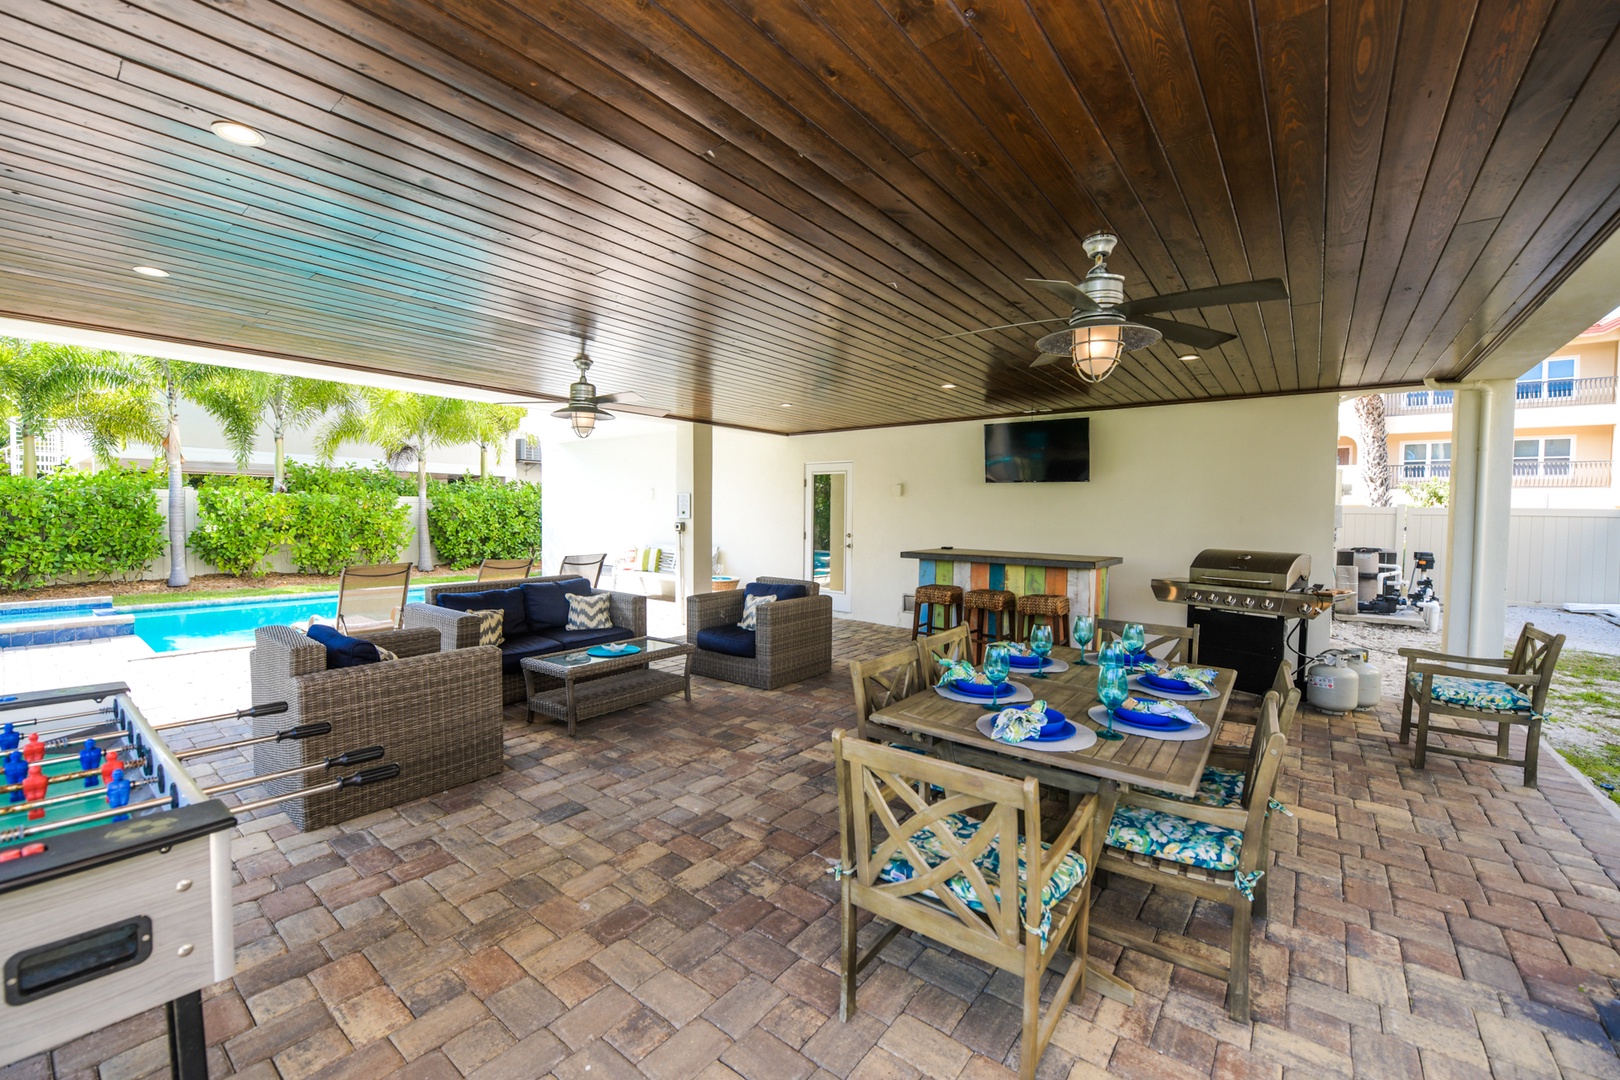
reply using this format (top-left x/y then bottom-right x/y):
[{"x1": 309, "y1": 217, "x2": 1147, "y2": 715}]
[{"x1": 191, "y1": 466, "x2": 410, "y2": 576}]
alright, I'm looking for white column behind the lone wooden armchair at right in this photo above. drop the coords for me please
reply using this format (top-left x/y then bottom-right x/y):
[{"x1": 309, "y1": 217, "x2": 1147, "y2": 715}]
[{"x1": 1442, "y1": 379, "x2": 1515, "y2": 657}]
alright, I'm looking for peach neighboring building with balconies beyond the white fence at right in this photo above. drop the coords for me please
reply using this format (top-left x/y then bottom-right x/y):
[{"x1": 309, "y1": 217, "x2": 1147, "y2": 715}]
[{"x1": 1338, "y1": 313, "x2": 1620, "y2": 508}]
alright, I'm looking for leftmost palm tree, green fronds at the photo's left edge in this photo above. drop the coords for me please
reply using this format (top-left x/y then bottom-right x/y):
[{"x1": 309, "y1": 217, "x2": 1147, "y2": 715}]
[{"x1": 0, "y1": 338, "x2": 146, "y2": 479}]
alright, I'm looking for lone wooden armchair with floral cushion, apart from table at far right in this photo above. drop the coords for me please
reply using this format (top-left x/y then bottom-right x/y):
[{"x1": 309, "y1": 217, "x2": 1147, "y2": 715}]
[{"x1": 1400, "y1": 623, "x2": 1563, "y2": 787}]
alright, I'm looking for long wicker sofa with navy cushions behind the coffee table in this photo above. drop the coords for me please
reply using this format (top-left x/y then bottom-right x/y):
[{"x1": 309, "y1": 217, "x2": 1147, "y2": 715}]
[{"x1": 400, "y1": 575, "x2": 646, "y2": 704}]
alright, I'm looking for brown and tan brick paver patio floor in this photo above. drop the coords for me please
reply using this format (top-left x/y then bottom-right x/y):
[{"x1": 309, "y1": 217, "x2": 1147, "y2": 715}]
[{"x1": 9, "y1": 622, "x2": 1620, "y2": 1080}]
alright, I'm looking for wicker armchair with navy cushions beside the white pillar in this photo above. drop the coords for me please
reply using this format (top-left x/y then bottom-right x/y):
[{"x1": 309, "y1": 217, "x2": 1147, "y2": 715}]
[{"x1": 687, "y1": 578, "x2": 833, "y2": 690}]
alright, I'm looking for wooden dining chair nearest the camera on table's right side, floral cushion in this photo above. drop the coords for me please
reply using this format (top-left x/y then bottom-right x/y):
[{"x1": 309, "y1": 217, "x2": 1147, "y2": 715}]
[{"x1": 1095, "y1": 688, "x2": 1299, "y2": 1023}]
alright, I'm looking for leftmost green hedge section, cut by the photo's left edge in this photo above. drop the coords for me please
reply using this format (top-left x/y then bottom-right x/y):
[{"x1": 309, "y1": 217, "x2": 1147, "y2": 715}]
[{"x1": 0, "y1": 468, "x2": 167, "y2": 589}]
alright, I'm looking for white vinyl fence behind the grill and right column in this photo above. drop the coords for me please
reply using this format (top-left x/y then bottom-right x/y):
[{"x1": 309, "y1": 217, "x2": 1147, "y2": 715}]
[{"x1": 1338, "y1": 507, "x2": 1620, "y2": 604}]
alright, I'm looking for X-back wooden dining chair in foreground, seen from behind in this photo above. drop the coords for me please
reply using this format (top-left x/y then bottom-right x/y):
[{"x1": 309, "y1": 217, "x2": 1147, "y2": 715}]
[{"x1": 833, "y1": 730, "x2": 1098, "y2": 1080}]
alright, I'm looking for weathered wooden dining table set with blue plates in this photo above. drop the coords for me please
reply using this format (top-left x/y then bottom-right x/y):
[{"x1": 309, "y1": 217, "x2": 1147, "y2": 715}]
[{"x1": 868, "y1": 648, "x2": 1238, "y2": 1006}]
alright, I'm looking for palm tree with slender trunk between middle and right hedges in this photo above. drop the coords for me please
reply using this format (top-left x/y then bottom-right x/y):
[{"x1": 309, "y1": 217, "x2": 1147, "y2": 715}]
[{"x1": 318, "y1": 387, "x2": 478, "y2": 573}]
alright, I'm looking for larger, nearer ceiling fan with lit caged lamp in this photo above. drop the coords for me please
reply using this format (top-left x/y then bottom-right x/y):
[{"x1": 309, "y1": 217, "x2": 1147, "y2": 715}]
[{"x1": 935, "y1": 233, "x2": 1288, "y2": 382}]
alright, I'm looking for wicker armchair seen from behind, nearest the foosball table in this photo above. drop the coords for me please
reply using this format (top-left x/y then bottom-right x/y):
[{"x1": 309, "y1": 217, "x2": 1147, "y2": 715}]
[{"x1": 251, "y1": 627, "x2": 504, "y2": 829}]
